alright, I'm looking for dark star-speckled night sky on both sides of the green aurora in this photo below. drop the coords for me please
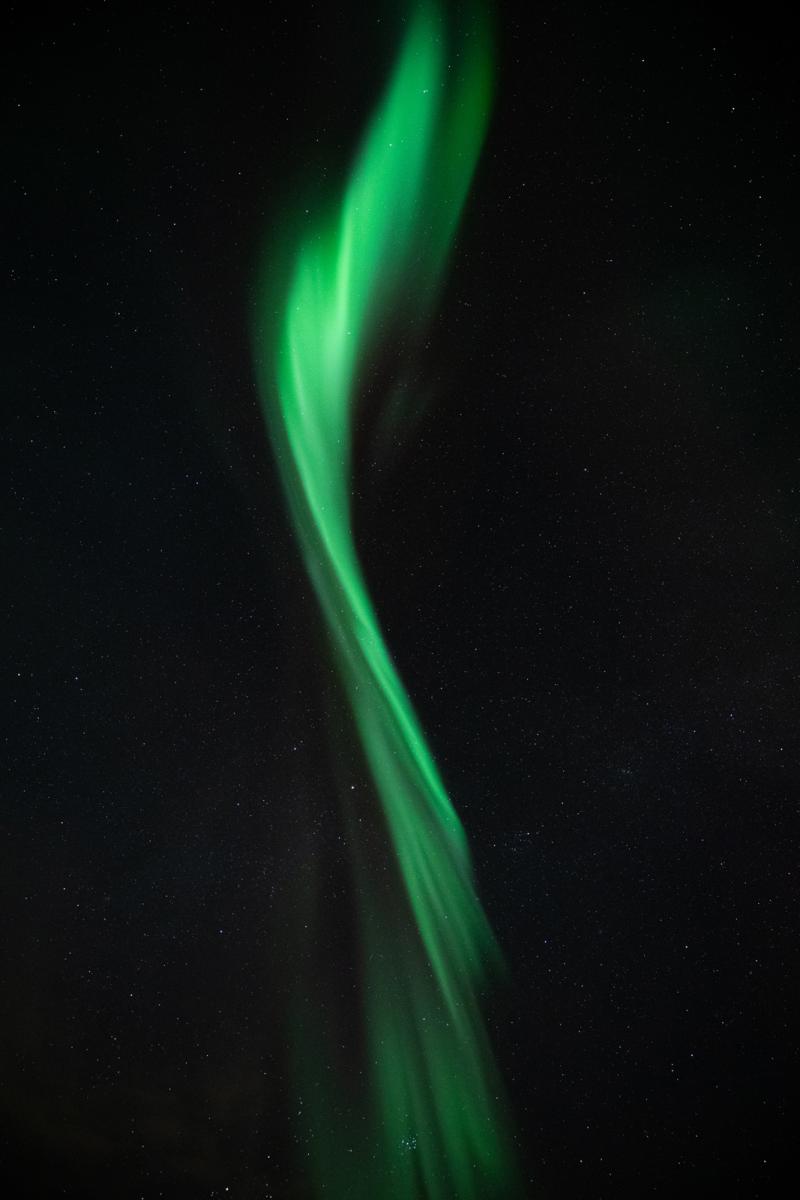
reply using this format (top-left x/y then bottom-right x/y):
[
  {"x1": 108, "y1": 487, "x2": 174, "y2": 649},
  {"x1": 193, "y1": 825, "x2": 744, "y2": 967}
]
[{"x1": 0, "y1": 0, "x2": 800, "y2": 1200}]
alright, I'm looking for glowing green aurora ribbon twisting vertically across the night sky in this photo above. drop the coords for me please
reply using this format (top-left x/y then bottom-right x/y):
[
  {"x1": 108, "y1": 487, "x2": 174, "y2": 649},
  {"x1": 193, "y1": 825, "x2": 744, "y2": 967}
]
[{"x1": 254, "y1": 4, "x2": 518, "y2": 1200}]
